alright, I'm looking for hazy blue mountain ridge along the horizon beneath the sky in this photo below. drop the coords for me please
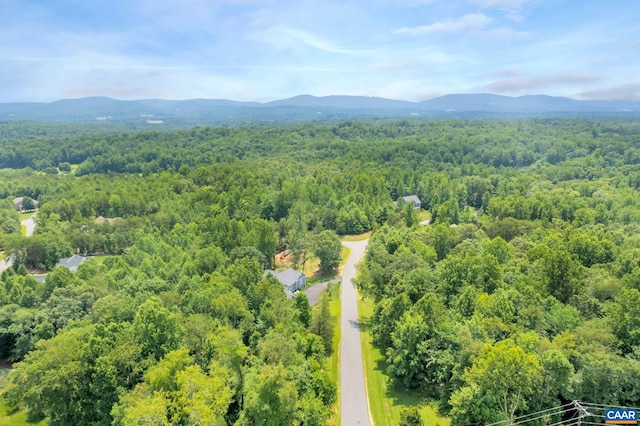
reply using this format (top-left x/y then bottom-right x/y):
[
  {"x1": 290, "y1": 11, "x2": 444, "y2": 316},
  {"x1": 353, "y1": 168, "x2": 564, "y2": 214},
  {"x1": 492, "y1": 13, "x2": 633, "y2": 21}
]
[{"x1": 0, "y1": 93, "x2": 640, "y2": 124}]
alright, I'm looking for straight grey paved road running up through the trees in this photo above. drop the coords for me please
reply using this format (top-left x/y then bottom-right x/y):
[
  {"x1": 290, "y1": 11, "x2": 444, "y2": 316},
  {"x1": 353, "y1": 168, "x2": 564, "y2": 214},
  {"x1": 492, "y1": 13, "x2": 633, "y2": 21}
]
[{"x1": 340, "y1": 240, "x2": 370, "y2": 426}]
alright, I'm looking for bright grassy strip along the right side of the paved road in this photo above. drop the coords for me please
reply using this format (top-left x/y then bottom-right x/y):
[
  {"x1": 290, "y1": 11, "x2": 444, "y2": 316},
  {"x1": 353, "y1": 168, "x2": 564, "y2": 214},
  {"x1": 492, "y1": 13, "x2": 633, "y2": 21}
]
[{"x1": 358, "y1": 297, "x2": 450, "y2": 426}]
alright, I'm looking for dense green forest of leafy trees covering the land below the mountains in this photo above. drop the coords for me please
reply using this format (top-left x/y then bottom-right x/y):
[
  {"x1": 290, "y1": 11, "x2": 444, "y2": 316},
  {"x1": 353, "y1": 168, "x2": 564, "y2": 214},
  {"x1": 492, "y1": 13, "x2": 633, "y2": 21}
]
[{"x1": 0, "y1": 119, "x2": 640, "y2": 425}]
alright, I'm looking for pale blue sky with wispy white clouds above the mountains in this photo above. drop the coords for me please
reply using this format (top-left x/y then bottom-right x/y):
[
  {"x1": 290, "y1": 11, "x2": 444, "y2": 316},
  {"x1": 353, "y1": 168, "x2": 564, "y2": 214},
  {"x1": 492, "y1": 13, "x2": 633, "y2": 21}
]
[{"x1": 0, "y1": 0, "x2": 640, "y2": 102}]
